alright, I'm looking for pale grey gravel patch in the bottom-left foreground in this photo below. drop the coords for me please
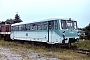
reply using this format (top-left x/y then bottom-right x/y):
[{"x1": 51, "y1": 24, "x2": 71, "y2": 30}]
[{"x1": 0, "y1": 47, "x2": 60, "y2": 60}]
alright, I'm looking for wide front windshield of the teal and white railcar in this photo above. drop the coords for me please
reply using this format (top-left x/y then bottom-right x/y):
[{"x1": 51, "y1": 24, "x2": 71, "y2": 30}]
[{"x1": 61, "y1": 20, "x2": 77, "y2": 29}]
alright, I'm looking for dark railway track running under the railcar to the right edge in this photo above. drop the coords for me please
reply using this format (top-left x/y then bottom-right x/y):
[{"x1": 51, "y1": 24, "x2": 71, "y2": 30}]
[{"x1": 2, "y1": 40, "x2": 90, "y2": 55}]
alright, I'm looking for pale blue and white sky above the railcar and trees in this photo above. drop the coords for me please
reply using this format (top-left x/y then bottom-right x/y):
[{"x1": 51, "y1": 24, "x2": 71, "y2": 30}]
[{"x1": 0, "y1": 0, "x2": 90, "y2": 28}]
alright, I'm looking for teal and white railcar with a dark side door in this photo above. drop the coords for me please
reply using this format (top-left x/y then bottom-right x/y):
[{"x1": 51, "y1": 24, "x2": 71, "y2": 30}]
[{"x1": 10, "y1": 19, "x2": 79, "y2": 44}]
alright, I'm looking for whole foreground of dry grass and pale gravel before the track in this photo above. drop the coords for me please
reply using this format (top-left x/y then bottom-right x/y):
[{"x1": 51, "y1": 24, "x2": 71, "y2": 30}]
[{"x1": 0, "y1": 40, "x2": 90, "y2": 60}]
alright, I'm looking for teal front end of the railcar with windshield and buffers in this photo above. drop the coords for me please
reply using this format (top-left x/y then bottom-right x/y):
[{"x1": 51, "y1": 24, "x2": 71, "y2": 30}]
[{"x1": 61, "y1": 20, "x2": 79, "y2": 43}]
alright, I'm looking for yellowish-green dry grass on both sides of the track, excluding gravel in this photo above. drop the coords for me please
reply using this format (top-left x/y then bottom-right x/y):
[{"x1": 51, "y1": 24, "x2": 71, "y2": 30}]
[{"x1": 0, "y1": 40, "x2": 90, "y2": 60}]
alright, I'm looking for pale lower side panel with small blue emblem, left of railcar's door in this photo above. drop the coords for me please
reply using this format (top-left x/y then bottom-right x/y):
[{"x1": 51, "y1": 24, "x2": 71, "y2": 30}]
[{"x1": 11, "y1": 31, "x2": 48, "y2": 42}]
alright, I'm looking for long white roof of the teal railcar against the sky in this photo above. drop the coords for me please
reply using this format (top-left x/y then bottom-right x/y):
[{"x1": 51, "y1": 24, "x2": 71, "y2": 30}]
[{"x1": 12, "y1": 17, "x2": 74, "y2": 26}]
